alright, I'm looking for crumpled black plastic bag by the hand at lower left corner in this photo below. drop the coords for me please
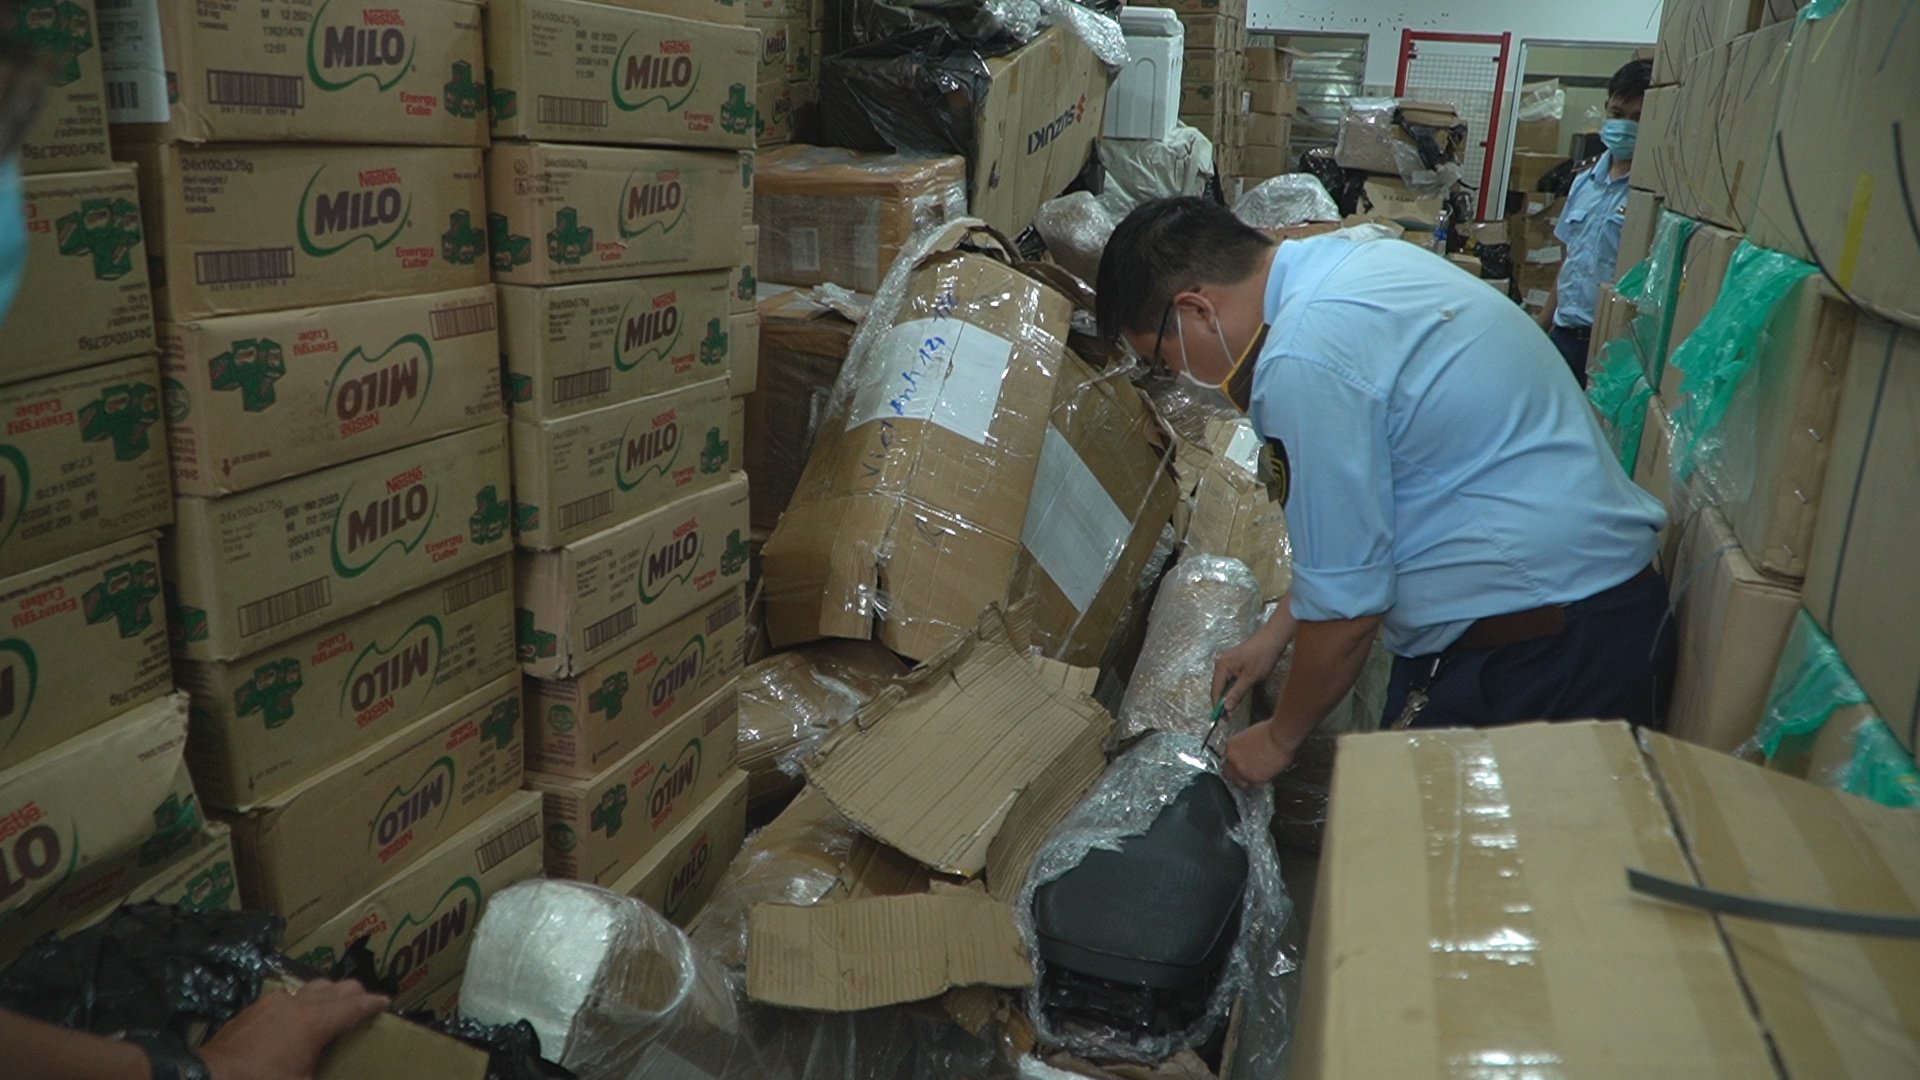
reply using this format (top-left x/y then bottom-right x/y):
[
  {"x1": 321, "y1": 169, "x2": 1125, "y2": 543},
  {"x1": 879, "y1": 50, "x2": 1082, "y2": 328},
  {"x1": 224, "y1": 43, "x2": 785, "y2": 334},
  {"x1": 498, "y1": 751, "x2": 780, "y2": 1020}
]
[{"x1": 0, "y1": 903, "x2": 286, "y2": 1049}]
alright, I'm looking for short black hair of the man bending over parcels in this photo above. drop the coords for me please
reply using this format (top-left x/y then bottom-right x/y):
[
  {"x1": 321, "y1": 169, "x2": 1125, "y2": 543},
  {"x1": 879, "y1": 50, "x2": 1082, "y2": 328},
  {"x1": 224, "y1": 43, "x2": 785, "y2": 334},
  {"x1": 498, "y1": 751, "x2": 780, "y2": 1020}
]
[{"x1": 1094, "y1": 196, "x2": 1273, "y2": 342}]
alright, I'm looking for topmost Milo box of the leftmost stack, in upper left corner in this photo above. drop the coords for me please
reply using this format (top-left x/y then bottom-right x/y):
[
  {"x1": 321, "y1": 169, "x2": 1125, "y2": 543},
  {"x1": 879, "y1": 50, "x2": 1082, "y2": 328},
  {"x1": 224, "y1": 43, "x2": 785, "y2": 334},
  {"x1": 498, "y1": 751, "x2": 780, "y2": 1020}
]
[{"x1": 15, "y1": 0, "x2": 111, "y2": 177}]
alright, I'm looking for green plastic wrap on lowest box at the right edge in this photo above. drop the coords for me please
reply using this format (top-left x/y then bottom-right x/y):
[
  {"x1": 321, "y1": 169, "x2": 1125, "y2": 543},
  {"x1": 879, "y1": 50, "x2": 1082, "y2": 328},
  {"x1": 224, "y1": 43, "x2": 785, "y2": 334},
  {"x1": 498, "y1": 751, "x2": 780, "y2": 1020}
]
[{"x1": 1736, "y1": 611, "x2": 1920, "y2": 809}]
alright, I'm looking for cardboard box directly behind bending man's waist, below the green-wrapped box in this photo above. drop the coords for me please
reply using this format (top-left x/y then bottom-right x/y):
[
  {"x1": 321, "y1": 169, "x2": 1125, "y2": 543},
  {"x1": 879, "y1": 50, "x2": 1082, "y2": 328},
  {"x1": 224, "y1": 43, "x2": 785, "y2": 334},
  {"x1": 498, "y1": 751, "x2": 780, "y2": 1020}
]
[{"x1": 1667, "y1": 507, "x2": 1801, "y2": 751}]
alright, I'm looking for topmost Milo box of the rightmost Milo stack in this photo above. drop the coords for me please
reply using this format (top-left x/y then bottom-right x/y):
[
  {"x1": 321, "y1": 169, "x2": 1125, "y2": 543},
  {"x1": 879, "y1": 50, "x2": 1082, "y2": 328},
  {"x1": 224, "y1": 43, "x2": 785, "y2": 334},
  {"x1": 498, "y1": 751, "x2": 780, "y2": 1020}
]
[{"x1": 486, "y1": 0, "x2": 758, "y2": 148}]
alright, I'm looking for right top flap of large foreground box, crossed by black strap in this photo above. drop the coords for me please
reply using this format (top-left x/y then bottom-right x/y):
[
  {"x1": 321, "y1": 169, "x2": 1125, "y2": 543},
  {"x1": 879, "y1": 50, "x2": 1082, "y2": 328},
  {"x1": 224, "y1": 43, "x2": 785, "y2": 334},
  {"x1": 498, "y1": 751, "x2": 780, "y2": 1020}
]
[{"x1": 1644, "y1": 734, "x2": 1920, "y2": 1080}]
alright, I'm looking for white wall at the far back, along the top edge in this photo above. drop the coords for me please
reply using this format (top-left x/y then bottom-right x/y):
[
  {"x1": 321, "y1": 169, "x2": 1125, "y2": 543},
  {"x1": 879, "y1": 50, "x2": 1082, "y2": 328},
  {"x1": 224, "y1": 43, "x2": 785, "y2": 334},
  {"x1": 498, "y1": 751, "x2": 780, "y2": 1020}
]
[{"x1": 1246, "y1": 0, "x2": 1661, "y2": 86}]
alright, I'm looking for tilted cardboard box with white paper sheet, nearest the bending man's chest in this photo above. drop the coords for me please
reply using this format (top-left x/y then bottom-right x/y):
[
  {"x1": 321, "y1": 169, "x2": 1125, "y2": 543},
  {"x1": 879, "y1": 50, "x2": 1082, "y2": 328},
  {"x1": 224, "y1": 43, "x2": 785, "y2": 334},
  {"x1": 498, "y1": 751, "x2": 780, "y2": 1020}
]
[{"x1": 1020, "y1": 354, "x2": 1179, "y2": 667}]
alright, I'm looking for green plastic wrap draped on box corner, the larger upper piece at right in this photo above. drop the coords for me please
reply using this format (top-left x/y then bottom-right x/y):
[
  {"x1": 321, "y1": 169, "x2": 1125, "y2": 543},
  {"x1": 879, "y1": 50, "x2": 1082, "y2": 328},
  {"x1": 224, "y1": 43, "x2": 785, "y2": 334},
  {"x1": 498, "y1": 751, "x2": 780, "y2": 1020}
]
[{"x1": 1670, "y1": 240, "x2": 1818, "y2": 505}]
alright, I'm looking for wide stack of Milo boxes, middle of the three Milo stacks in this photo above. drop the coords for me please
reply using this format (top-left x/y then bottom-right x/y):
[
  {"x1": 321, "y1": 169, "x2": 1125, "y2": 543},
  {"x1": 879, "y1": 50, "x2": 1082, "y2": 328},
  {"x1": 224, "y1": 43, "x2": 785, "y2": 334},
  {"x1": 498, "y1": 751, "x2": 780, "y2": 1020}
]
[{"x1": 91, "y1": 0, "x2": 540, "y2": 1003}]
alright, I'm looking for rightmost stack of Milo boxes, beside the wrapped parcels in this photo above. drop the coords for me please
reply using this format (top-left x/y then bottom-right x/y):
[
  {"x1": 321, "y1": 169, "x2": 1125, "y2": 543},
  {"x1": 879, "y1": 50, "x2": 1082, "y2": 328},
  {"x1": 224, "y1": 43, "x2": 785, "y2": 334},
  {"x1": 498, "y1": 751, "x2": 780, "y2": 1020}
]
[{"x1": 488, "y1": 0, "x2": 764, "y2": 915}]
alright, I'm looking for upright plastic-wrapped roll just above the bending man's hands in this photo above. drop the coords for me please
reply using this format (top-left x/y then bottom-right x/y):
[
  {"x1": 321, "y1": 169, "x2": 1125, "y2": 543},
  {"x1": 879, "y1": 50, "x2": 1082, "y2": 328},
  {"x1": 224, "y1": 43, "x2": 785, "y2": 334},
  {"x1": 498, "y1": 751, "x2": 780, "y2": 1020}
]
[{"x1": 1117, "y1": 555, "x2": 1260, "y2": 740}]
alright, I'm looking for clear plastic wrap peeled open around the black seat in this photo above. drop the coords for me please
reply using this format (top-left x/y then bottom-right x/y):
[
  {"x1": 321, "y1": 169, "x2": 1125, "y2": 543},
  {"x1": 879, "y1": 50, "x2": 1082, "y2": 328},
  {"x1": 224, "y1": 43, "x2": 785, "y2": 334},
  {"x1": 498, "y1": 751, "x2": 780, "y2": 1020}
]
[{"x1": 1014, "y1": 732, "x2": 1294, "y2": 1076}]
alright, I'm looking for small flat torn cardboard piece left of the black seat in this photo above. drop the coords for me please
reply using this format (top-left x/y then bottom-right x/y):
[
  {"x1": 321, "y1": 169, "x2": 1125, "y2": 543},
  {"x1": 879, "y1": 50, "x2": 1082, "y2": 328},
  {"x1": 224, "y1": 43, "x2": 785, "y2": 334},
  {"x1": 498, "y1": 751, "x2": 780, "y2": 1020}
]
[{"x1": 747, "y1": 886, "x2": 1033, "y2": 1011}]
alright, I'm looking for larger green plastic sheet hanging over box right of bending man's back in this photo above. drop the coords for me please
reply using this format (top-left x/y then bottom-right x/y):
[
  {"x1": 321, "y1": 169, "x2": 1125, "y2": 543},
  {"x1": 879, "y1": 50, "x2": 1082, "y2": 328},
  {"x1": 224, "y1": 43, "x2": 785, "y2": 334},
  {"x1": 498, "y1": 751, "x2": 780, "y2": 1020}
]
[{"x1": 1670, "y1": 240, "x2": 1818, "y2": 502}]
